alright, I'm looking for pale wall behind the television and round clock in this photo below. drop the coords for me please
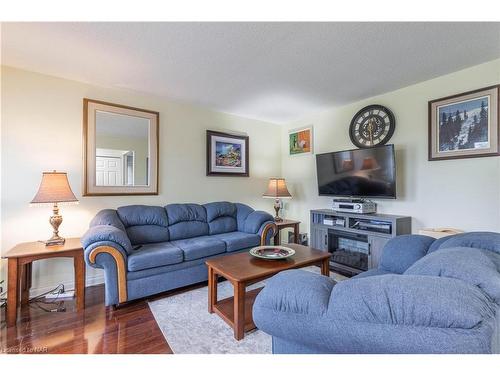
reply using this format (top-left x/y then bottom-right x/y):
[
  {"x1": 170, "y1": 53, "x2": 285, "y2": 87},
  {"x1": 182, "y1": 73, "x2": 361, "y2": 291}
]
[{"x1": 281, "y1": 60, "x2": 500, "y2": 236}]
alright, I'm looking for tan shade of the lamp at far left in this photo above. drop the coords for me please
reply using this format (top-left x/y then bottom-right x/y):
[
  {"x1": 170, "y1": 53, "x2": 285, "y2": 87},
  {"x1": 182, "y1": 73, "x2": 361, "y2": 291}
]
[{"x1": 31, "y1": 171, "x2": 78, "y2": 203}]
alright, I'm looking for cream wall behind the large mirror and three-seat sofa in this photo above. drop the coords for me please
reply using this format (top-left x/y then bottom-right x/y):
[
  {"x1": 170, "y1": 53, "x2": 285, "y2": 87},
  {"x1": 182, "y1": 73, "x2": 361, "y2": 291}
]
[{"x1": 0, "y1": 67, "x2": 281, "y2": 291}]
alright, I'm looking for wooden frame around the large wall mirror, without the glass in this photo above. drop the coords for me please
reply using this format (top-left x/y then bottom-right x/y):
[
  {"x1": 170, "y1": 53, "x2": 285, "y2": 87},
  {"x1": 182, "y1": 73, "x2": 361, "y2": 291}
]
[{"x1": 83, "y1": 98, "x2": 160, "y2": 196}]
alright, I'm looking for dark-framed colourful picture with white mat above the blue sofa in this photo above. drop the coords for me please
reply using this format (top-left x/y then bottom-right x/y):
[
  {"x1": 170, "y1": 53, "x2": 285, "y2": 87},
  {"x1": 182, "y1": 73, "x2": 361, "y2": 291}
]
[{"x1": 207, "y1": 130, "x2": 249, "y2": 177}]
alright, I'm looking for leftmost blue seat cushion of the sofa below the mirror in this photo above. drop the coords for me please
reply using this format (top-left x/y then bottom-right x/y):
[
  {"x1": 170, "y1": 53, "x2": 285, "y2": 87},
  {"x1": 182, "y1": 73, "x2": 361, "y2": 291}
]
[{"x1": 128, "y1": 242, "x2": 184, "y2": 271}]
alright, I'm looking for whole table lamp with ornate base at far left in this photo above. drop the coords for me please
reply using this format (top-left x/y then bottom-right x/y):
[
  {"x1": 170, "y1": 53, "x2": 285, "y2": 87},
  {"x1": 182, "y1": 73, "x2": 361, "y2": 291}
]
[{"x1": 31, "y1": 171, "x2": 78, "y2": 246}]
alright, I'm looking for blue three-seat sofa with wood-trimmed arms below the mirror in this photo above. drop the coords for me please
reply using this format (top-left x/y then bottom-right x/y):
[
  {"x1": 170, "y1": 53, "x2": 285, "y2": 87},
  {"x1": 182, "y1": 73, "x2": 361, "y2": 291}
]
[{"x1": 81, "y1": 202, "x2": 276, "y2": 306}]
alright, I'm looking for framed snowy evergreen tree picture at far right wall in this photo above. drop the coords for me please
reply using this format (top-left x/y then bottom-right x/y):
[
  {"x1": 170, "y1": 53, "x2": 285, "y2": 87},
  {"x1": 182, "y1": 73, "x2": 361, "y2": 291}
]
[{"x1": 429, "y1": 85, "x2": 500, "y2": 160}]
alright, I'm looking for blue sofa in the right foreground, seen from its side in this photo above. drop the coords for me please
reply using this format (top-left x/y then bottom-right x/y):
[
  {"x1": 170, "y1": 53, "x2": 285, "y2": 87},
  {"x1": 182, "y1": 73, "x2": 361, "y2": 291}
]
[{"x1": 253, "y1": 232, "x2": 500, "y2": 353}]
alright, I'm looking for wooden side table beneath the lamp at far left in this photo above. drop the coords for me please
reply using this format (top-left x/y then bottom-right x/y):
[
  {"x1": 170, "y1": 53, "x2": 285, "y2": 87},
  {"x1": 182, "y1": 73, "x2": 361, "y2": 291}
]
[{"x1": 2, "y1": 238, "x2": 85, "y2": 327}]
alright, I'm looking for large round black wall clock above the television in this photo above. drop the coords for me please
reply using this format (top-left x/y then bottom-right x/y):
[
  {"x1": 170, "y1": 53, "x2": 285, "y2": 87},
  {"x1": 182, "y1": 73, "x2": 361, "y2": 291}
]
[{"x1": 349, "y1": 104, "x2": 396, "y2": 148}]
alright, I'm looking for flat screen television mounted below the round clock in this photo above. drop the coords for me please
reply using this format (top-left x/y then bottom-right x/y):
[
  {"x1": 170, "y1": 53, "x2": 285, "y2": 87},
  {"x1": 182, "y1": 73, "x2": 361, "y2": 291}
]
[{"x1": 316, "y1": 145, "x2": 396, "y2": 199}]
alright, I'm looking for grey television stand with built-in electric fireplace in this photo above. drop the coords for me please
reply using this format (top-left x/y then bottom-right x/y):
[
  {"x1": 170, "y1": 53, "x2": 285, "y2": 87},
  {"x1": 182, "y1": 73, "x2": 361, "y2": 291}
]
[{"x1": 310, "y1": 209, "x2": 411, "y2": 276}]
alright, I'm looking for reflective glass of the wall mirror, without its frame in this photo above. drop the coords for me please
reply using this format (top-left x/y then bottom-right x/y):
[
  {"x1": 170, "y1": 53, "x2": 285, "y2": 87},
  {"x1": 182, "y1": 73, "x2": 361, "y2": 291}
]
[{"x1": 95, "y1": 111, "x2": 150, "y2": 186}]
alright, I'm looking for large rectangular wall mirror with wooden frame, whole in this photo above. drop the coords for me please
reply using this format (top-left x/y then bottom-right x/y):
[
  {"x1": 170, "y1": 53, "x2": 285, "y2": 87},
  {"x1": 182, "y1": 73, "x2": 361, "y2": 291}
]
[{"x1": 83, "y1": 99, "x2": 159, "y2": 196}]
